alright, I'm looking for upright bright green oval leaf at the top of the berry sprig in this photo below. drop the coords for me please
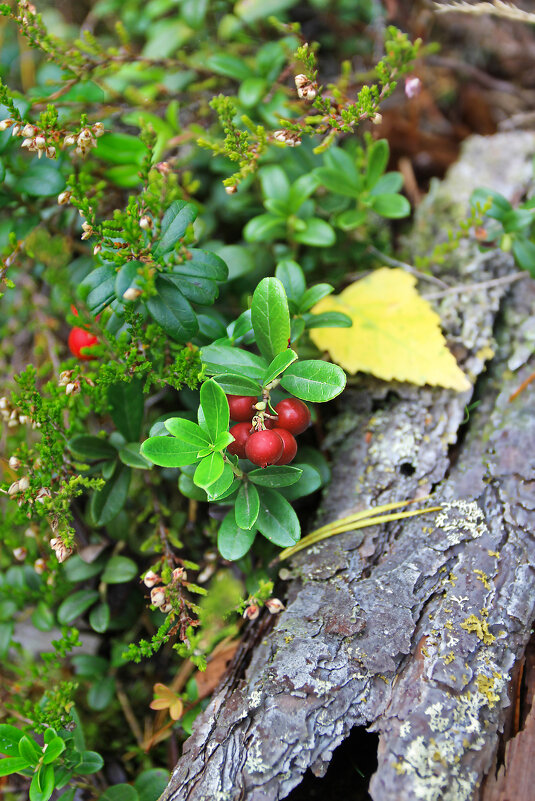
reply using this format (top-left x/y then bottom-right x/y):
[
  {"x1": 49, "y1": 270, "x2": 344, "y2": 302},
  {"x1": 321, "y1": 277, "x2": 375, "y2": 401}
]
[{"x1": 251, "y1": 278, "x2": 290, "y2": 362}]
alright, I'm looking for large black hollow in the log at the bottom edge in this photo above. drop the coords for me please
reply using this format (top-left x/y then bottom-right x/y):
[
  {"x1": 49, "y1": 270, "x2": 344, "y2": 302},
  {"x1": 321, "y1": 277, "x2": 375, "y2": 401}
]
[{"x1": 287, "y1": 726, "x2": 379, "y2": 801}]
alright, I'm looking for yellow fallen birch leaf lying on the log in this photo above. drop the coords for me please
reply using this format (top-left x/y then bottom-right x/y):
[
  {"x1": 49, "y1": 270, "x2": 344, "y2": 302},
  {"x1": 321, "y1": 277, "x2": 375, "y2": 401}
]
[{"x1": 310, "y1": 267, "x2": 471, "y2": 392}]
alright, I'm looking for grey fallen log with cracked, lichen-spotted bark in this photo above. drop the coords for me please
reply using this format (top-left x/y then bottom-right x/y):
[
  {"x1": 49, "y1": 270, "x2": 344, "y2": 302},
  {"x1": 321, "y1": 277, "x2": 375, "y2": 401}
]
[{"x1": 162, "y1": 133, "x2": 535, "y2": 801}]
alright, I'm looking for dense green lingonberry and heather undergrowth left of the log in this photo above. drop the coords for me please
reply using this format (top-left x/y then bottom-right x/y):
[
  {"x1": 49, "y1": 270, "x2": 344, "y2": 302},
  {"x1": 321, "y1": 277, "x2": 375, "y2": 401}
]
[{"x1": 0, "y1": 0, "x2": 426, "y2": 801}]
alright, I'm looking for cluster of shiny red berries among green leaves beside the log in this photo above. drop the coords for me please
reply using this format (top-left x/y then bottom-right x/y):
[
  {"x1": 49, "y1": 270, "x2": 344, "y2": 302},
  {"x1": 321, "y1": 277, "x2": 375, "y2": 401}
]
[{"x1": 227, "y1": 395, "x2": 310, "y2": 467}]
